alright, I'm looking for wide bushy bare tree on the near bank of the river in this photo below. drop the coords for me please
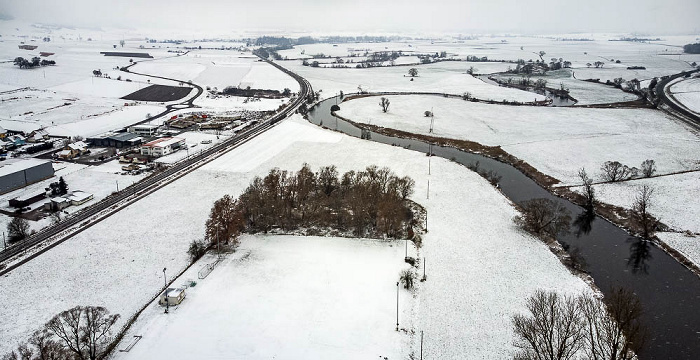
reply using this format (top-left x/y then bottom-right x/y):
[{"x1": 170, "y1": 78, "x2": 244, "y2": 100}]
[{"x1": 515, "y1": 198, "x2": 571, "y2": 238}]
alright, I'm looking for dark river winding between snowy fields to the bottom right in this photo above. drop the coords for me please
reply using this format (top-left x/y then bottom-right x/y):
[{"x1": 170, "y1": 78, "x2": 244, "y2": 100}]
[{"x1": 309, "y1": 98, "x2": 700, "y2": 359}]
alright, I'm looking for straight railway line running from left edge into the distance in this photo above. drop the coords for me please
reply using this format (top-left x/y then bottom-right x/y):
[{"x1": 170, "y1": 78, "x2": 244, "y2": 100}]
[{"x1": 0, "y1": 57, "x2": 312, "y2": 276}]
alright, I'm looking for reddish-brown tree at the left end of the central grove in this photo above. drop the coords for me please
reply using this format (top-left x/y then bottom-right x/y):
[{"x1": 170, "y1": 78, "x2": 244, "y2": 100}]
[{"x1": 205, "y1": 195, "x2": 244, "y2": 248}]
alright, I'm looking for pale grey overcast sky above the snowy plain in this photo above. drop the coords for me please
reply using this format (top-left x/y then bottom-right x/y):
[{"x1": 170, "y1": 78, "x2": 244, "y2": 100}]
[{"x1": 0, "y1": 0, "x2": 700, "y2": 35}]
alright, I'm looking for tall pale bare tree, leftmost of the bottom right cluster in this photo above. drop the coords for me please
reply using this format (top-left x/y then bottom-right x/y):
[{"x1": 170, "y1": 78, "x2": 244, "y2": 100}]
[{"x1": 512, "y1": 290, "x2": 586, "y2": 360}]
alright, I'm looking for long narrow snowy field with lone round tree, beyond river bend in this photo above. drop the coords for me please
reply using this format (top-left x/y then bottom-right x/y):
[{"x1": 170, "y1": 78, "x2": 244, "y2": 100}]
[{"x1": 279, "y1": 61, "x2": 545, "y2": 102}]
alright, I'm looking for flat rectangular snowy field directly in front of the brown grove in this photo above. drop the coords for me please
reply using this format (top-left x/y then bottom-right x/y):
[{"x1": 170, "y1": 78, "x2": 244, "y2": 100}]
[{"x1": 112, "y1": 236, "x2": 414, "y2": 359}]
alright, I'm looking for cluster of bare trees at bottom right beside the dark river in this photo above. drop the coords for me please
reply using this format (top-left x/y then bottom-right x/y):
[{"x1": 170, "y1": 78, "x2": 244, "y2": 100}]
[{"x1": 512, "y1": 288, "x2": 646, "y2": 360}]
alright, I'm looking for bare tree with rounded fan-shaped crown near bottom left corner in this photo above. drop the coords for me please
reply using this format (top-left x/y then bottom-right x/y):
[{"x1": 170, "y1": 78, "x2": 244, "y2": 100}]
[{"x1": 46, "y1": 306, "x2": 119, "y2": 360}]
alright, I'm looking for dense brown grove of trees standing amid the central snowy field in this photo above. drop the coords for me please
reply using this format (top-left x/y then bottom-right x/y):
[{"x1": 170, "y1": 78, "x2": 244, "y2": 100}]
[{"x1": 206, "y1": 164, "x2": 415, "y2": 245}]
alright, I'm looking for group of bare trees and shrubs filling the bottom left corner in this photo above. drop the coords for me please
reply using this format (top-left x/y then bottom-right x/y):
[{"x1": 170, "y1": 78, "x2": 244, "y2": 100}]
[{"x1": 2, "y1": 306, "x2": 120, "y2": 360}]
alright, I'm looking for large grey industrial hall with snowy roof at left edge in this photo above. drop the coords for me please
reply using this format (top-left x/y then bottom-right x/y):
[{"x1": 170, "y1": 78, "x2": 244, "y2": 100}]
[{"x1": 0, "y1": 159, "x2": 53, "y2": 194}]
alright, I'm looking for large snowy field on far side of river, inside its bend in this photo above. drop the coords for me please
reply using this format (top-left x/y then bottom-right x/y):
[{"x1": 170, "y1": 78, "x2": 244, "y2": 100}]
[{"x1": 338, "y1": 95, "x2": 700, "y2": 184}]
